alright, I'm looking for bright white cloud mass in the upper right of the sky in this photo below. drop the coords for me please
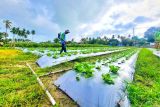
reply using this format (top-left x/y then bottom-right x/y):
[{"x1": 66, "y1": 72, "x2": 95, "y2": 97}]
[{"x1": 77, "y1": 0, "x2": 160, "y2": 38}]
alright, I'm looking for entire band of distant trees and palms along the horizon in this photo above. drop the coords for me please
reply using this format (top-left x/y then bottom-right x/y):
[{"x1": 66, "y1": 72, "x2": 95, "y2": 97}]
[{"x1": 0, "y1": 20, "x2": 160, "y2": 48}]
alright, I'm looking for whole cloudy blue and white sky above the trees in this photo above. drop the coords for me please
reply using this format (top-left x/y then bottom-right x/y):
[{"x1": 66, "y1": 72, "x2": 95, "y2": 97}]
[{"x1": 0, "y1": 0, "x2": 160, "y2": 42}]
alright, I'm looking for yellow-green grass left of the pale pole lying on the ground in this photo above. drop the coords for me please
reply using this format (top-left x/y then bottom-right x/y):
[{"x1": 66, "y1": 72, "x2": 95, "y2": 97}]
[{"x1": 0, "y1": 48, "x2": 50, "y2": 107}]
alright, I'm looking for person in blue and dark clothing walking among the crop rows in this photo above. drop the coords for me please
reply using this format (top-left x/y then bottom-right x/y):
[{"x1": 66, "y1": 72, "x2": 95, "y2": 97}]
[{"x1": 58, "y1": 30, "x2": 70, "y2": 54}]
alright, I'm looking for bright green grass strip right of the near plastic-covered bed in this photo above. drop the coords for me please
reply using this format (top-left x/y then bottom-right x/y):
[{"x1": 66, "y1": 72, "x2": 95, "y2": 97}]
[{"x1": 127, "y1": 49, "x2": 160, "y2": 107}]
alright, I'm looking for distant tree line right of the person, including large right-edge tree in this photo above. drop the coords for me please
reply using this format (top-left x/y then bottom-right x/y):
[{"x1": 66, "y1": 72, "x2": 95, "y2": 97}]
[{"x1": 54, "y1": 27, "x2": 160, "y2": 47}]
